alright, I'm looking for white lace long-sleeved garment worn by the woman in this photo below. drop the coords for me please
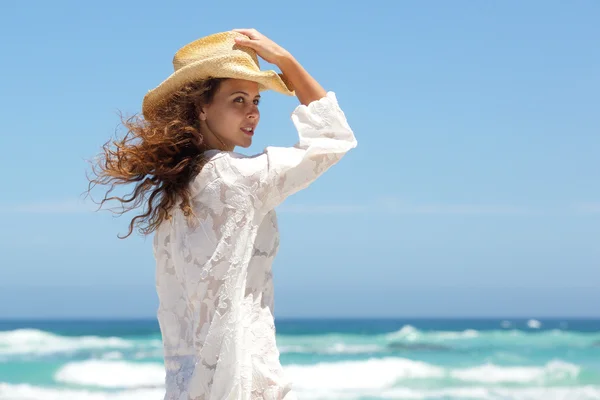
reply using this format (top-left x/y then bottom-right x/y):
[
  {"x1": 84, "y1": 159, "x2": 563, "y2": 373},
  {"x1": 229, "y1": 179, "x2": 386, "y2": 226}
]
[{"x1": 154, "y1": 92, "x2": 357, "y2": 400}]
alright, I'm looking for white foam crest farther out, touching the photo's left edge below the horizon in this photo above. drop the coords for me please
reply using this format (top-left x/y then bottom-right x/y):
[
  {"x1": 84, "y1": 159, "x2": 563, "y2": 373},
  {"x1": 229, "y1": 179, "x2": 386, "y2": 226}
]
[{"x1": 0, "y1": 329, "x2": 134, "y2": 355}]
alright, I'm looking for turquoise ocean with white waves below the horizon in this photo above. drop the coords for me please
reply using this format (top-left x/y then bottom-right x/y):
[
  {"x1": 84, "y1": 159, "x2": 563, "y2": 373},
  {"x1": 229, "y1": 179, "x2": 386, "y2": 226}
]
[{"x1": 0, "y1": 318, "x2": 600, "y2": 400}]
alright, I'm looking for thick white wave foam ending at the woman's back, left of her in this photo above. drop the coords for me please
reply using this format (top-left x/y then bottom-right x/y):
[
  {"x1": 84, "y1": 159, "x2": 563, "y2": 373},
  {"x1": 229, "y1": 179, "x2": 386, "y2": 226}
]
[{"x1": 54, "y1": 360, "x2": 165, "y2": 388}]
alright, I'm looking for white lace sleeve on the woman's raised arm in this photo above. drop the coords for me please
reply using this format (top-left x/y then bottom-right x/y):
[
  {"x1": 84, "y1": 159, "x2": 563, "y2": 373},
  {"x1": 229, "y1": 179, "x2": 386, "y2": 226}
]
[{"x1": 218, "y1": 92, "x2": 357, "y2": 212}]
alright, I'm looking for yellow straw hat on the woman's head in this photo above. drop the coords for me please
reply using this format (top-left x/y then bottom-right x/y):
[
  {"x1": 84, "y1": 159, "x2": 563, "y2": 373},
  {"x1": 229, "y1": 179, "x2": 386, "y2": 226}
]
[{"x1": 142, "y1": 31, "x2": 294, "y2": 119}]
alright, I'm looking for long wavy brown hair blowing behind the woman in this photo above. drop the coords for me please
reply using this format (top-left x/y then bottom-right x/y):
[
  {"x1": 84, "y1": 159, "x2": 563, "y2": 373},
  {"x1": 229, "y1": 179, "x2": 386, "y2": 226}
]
[{"x1": 86, "y1": 78, "x2": 224, "y2": 239}]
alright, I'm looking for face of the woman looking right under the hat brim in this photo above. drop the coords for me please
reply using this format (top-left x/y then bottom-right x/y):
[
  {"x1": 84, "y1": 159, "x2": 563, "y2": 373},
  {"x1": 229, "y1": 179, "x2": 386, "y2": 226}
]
[{"x1": 199, "y1": 79, "x2": 260, "y2": 151}]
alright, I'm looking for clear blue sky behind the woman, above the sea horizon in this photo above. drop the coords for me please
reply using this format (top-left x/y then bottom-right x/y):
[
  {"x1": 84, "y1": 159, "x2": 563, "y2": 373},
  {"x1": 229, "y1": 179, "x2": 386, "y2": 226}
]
[{"x1": 0, "y1": 1, "x2": 600, "y2": 318}]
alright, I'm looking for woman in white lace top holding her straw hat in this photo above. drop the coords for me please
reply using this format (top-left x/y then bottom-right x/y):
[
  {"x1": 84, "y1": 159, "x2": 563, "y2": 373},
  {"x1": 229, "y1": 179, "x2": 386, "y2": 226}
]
[{"x1": 92, "y1": 29, "x2": 357, "y2": 400}]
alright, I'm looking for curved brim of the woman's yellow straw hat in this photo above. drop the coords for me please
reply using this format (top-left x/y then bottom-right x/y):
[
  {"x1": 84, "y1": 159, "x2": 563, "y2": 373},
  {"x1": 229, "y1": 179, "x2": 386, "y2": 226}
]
[{"x1": 142, "y1": 56, "x2": 295, "y2": 119}]
